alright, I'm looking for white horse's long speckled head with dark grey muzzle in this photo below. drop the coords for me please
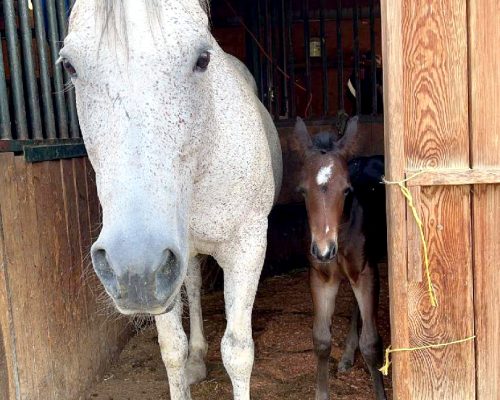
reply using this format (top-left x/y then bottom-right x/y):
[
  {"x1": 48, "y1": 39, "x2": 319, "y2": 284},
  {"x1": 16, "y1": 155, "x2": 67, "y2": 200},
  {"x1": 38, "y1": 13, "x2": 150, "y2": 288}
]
[{"x1": 60, "y1": 0, "x2": 213, "y2": 314}]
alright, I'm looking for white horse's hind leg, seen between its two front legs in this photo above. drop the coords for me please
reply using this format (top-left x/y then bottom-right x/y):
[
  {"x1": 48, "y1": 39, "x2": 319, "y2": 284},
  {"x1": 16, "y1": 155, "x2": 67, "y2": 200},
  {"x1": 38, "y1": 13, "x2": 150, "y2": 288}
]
[{"x1": 184, "y1": 257, "x2": 208, "y2": 385}]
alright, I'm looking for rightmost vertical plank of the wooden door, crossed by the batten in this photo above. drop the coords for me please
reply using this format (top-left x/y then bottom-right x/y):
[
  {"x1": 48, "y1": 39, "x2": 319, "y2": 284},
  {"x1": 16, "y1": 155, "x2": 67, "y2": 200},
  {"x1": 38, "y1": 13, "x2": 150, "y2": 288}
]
[{"x1": 469, "y1": 0, "x2": 500, "y2": 400}]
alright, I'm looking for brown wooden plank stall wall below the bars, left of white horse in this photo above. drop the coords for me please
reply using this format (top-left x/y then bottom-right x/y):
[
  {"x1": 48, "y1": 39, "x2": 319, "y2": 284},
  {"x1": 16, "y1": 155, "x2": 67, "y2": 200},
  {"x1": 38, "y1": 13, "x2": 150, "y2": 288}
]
[{"x1": 0, "y1": 153, "x2": 129, "y2": 400}]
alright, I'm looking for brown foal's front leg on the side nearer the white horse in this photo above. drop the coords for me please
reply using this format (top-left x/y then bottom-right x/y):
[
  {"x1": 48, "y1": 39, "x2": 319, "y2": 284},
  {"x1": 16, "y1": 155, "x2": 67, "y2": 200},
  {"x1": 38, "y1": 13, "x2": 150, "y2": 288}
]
[{"x1": 310, "y1": 268, "x2": 340, "y2": 400}]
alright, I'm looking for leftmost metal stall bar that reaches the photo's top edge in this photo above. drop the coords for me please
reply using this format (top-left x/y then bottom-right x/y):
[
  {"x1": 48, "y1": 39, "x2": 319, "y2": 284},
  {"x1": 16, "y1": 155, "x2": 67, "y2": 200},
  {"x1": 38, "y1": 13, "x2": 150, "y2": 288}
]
[{"x1": 3, "y1": 0, "x2": 29, "y2": 139}]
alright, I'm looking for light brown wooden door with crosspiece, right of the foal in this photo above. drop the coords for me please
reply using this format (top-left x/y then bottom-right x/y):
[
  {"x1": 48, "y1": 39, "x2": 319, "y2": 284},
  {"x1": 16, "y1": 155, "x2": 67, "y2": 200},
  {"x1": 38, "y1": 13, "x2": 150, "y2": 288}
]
[{"x1": 382, "y1": 0, "x2": 500, "y2": 400}]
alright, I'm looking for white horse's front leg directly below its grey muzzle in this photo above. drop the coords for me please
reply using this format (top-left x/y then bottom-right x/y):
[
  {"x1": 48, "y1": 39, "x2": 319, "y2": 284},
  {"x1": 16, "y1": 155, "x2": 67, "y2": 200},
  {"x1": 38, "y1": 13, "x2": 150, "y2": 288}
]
[{"x1": 155, "y1": 294, "x2": 191, "y2": 400}]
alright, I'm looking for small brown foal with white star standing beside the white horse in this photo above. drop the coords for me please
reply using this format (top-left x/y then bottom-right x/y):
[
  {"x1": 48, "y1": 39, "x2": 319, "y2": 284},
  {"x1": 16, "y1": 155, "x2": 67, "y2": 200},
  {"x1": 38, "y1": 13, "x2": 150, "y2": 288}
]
[{"x1": 295, "y1": 118, "x2": 386, "y2": 400}]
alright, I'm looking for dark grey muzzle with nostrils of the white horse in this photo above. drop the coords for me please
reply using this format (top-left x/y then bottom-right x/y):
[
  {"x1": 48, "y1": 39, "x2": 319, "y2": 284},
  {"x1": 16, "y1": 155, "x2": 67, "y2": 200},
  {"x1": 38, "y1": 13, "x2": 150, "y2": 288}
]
[{"x1": 92, "y1": 247, "x2": 181, "y2": 315}]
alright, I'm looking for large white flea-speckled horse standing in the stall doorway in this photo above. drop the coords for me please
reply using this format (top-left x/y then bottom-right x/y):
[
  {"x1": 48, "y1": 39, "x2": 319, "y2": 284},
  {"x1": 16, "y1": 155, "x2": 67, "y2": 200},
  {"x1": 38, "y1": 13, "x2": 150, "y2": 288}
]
[{"x1": 60, "y1": 0, "x2": 282, "y2": 400}]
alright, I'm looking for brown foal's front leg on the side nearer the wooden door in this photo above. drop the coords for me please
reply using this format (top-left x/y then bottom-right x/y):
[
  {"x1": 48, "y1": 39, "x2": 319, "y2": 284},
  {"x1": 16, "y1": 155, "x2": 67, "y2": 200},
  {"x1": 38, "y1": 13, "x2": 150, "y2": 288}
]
[{"x1": 351, "y1": 263, "x2": 386, "y2": 400}]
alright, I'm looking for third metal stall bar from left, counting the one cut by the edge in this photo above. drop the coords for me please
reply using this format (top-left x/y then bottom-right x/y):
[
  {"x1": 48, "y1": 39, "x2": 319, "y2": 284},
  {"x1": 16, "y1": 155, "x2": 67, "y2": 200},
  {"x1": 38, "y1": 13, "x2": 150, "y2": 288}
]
[{"x1": 18, "y1": 0, "x2": 43, "y2": 139}]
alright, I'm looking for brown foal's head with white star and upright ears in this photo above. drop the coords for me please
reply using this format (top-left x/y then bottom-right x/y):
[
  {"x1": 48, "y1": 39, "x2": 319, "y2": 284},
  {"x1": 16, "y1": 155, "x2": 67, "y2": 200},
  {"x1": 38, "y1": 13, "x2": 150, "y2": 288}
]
[{"x1": 295, "y1": 117, "x2": 358, "y2": 262}]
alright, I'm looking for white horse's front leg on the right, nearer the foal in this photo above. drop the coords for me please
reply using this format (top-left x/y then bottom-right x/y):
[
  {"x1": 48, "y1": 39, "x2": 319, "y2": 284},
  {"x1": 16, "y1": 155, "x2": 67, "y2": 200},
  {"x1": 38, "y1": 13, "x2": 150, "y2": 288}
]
[{"x1": 216, "y1": 219, "x2": 267, "y2": 400}]
